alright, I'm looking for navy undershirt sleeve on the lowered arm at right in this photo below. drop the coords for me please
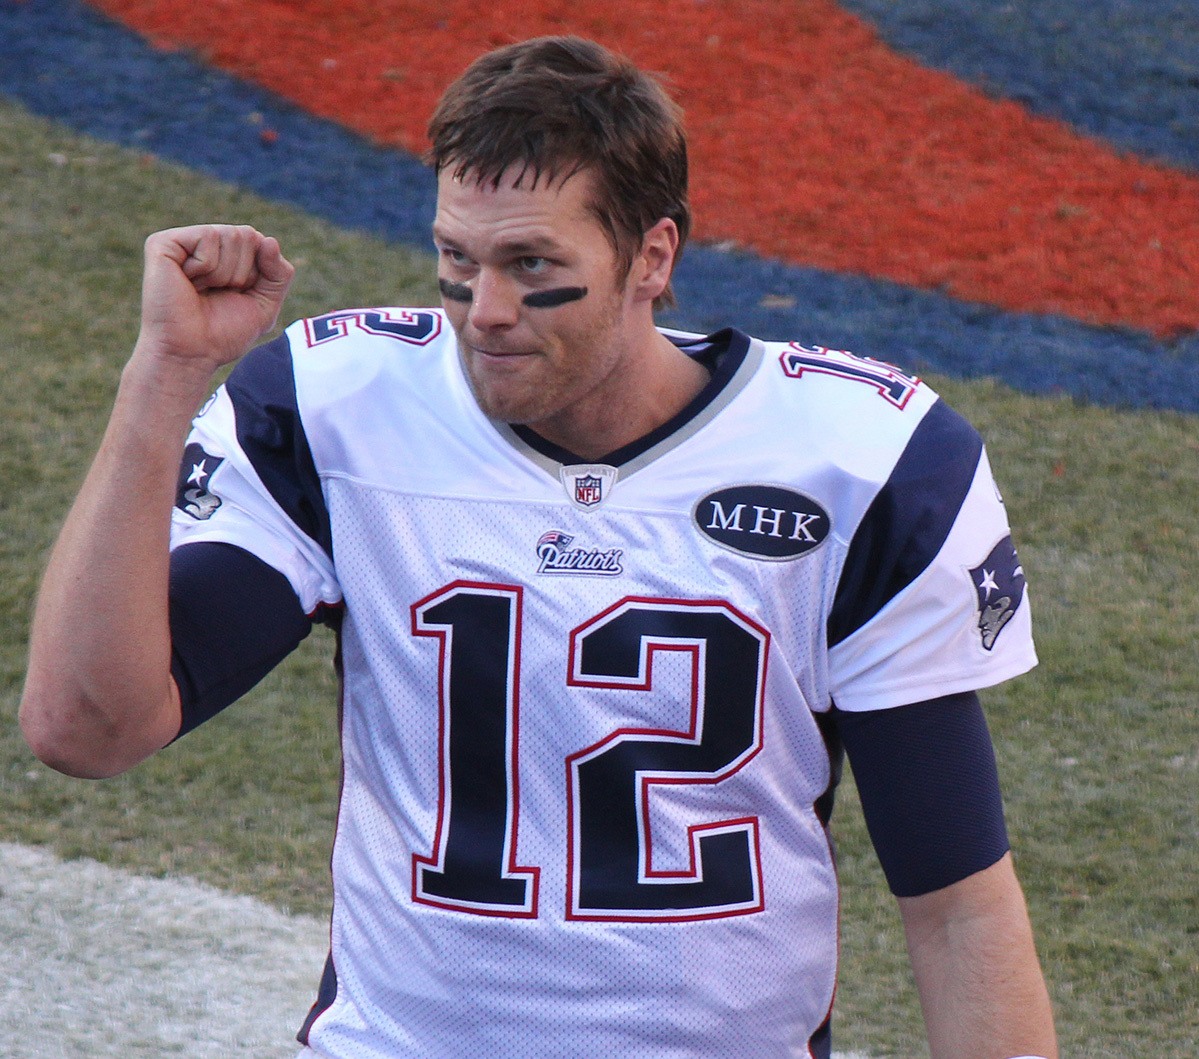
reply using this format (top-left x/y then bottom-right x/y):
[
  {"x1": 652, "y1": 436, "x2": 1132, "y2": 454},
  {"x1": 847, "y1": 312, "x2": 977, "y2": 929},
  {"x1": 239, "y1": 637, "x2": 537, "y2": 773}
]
[{"x1": 833, "y1": 692, "x2": 1008, "y2": 897}]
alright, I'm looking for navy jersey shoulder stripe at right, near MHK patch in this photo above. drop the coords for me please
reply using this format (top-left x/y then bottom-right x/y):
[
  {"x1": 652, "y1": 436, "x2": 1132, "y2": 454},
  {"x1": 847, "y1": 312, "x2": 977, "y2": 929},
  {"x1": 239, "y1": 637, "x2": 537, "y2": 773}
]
[{"x1": 829, "y1": 401, "x2": 982, "y2": 646}]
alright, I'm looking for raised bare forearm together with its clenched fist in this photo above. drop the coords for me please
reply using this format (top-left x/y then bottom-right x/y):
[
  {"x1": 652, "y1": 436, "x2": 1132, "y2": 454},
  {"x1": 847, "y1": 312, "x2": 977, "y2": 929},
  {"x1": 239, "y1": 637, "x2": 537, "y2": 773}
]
[{"x1": 20, "y1": 224, "x2": 294, "y2": 776}]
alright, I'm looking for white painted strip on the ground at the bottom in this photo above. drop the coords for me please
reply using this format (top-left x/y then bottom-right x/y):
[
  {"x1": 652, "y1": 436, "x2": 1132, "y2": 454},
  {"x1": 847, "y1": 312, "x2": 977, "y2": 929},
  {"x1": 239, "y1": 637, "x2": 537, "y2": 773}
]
[{"x1": 0, "y1": 842, "x2": 882, "y2": 1059}]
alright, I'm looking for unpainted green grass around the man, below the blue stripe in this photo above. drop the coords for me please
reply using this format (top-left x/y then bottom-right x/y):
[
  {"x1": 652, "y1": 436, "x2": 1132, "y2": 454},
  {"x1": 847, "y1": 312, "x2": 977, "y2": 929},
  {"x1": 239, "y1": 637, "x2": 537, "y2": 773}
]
[{"x1": 0, "y1": 95, "x2": 1199, "y2": 1059}]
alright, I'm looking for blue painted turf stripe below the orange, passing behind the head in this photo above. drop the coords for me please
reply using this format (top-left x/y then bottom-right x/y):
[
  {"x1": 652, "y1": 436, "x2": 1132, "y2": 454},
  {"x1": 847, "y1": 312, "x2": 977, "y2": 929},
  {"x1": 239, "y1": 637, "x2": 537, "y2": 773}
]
[{"x1": 0, "y1": 0, "x2": 1199, "y2": 413}]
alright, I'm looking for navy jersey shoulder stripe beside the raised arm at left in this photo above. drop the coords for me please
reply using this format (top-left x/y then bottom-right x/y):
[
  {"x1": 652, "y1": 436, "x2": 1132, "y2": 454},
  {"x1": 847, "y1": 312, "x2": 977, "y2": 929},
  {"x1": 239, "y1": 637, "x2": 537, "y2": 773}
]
[{"x1": 225, "y1": 335, "x2": 333, "y2": 556}]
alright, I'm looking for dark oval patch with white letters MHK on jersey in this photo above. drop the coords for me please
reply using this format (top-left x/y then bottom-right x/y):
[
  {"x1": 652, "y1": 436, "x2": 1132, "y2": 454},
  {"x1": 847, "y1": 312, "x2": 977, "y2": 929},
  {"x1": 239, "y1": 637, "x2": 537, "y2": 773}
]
[{"x1": 693, "y1": 485, "x2": 830, "y2": 560}]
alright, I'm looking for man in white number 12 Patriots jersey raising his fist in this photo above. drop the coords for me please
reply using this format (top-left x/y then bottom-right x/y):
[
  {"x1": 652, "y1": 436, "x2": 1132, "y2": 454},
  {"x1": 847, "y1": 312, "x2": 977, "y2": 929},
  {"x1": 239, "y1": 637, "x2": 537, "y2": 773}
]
[{"x1": 22, "y1": 38, "x2": 1056, "y2": 1059}]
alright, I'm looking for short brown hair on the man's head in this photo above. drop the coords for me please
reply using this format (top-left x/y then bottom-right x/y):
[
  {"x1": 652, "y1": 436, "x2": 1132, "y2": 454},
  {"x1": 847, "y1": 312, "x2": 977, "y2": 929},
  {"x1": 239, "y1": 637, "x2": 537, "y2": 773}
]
[{"x1": 428, "y1": 37, "x2": 691, "y2": 305}]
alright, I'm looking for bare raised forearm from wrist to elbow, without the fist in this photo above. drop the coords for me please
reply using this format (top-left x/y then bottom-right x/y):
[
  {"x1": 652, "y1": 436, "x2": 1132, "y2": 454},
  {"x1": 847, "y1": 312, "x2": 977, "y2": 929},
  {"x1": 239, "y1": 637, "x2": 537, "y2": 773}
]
[{"x1": 22, "y1": 350, "x2": 209, "y2": 776}]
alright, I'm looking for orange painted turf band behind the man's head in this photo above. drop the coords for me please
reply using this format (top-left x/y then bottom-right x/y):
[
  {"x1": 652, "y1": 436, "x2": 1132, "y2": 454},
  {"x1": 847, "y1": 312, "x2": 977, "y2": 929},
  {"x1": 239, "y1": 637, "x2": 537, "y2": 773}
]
[{"x1": 92, "y1": 0, "x2": 1199, "y2": 335}]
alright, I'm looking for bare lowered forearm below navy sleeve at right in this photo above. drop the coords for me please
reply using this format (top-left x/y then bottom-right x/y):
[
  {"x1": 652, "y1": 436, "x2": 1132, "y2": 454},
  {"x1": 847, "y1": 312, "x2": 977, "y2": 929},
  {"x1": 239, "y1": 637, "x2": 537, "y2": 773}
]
[{"x1": 899, "y1": 856, "x2": 1058, "y2": 1059}]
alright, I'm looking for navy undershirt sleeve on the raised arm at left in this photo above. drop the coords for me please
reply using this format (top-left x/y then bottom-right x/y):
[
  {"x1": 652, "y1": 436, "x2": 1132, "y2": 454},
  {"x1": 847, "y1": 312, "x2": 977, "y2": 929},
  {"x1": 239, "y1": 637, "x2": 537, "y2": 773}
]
[{"x1": 170, "y1": 542, "x2": 313, "y2": 735}]
